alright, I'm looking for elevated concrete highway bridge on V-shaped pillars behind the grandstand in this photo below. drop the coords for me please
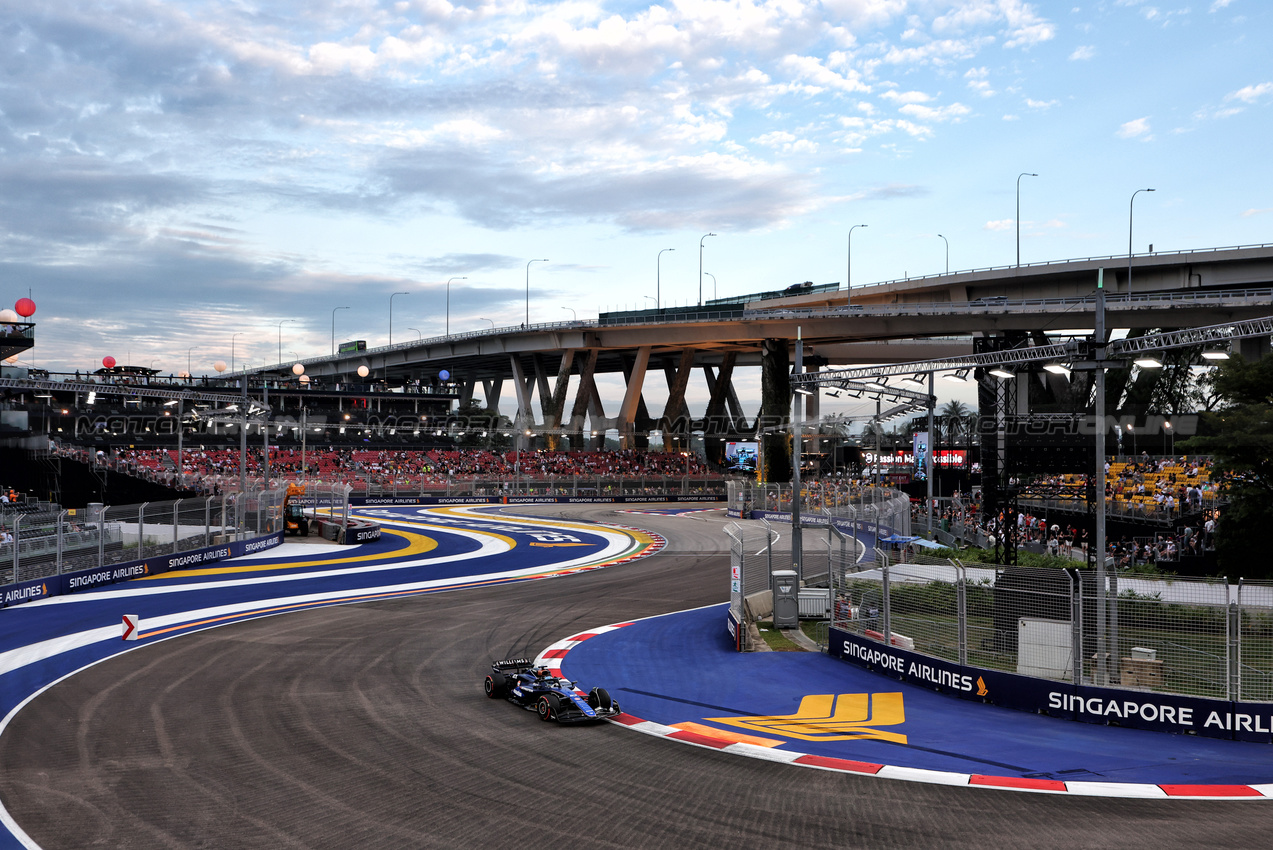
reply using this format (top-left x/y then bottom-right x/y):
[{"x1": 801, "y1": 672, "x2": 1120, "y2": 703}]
[{"x1": 227, "y1": 244, "x2": 1273, "y2": 445}]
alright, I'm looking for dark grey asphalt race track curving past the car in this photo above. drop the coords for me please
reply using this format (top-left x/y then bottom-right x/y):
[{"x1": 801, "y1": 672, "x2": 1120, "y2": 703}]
[{"x1": 0, "y1": 506, "x2": 1273, "y2": 850}]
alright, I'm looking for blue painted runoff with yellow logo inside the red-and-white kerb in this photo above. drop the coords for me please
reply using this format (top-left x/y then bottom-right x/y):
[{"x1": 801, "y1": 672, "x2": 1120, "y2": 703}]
[{"x1": 561, "y1": 604, "x2": 1273, "y2": 785}]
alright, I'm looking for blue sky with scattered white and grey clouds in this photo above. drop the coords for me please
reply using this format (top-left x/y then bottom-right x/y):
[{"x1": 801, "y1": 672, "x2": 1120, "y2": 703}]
[{"x1": 0, "y1": 0, "x2": 1273, "y2": 419}]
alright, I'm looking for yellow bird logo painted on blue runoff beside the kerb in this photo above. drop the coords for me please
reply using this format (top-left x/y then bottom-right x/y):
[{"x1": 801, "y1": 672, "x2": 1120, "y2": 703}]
[{"x1": 707, "y1": 693, "x2": 906, "y2": 744}]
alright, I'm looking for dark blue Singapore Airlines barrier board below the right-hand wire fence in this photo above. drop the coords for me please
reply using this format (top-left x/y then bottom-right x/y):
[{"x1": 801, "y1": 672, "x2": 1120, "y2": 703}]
[{"x1": 829, "y1": 629, "x2": 1273, "y2": 743}]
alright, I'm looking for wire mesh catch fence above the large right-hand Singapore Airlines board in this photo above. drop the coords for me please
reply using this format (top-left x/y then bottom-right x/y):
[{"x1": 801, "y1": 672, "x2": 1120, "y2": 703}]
[{"x1": 830, "y1": 554, "x2": 1273, "y2": 702}]
